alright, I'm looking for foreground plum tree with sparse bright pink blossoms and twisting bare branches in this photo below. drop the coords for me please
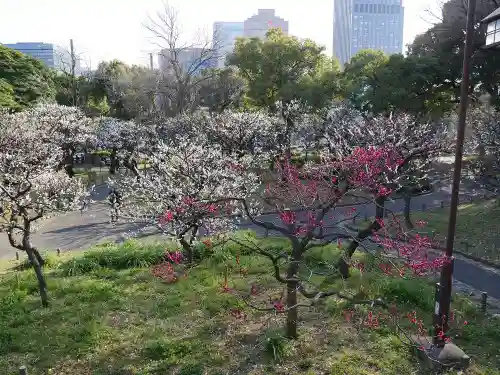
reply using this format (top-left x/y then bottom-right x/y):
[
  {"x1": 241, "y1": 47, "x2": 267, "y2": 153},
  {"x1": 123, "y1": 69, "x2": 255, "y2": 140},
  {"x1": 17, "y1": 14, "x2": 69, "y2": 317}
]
[{"x1": 230, "y1": 146, "x2": 454, "y2": 338}]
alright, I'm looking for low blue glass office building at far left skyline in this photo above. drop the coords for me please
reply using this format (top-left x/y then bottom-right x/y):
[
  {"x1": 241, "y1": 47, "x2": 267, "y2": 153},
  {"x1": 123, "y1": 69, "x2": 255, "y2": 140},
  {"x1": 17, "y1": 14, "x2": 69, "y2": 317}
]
[{"x1": 4, "y1": 42, "x2": 80, "y2": 74}]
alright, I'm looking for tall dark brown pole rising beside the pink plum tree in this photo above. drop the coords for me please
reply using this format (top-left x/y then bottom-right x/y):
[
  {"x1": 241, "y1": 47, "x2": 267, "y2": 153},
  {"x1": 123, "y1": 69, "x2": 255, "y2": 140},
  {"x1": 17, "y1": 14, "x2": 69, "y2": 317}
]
[{"x1": 434, "y1": 0, "x2": 476, "y2": 345}]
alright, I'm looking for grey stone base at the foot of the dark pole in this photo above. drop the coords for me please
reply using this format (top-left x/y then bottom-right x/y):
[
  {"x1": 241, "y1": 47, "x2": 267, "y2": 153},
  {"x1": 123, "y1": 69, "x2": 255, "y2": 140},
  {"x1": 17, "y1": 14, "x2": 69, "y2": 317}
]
[{"x1": 411, "y1": 336, "x2": 470, "y2": 370}]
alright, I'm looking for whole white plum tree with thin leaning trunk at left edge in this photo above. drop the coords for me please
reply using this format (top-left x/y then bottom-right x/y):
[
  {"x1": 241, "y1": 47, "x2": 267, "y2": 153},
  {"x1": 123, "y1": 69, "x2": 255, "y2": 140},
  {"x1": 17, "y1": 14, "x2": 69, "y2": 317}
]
[{"x1": 0, "y1": 107, "x2": 89, "y2": 306}]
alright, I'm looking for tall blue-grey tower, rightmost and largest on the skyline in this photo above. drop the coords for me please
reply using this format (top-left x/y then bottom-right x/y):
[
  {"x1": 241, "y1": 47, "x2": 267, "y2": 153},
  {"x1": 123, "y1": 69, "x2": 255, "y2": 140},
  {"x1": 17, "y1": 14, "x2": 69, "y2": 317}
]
[{"x1": 333, "y1": 0, "x2": 404, "y2": 65}]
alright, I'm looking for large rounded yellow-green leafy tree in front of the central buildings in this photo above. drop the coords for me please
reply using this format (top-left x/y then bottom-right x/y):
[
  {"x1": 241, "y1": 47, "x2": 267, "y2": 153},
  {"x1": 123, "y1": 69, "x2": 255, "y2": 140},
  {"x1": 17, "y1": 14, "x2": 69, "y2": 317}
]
[{"x1": 227, "y1": 29, "x2": 340, "y2": 155}]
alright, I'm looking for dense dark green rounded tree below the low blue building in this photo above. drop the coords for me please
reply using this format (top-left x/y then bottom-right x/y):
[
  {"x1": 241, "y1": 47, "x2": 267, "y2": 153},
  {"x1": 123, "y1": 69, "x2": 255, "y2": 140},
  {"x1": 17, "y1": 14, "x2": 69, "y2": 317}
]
[{"x1": 0, "y1": 45, "x2": 55, "y2": 110}]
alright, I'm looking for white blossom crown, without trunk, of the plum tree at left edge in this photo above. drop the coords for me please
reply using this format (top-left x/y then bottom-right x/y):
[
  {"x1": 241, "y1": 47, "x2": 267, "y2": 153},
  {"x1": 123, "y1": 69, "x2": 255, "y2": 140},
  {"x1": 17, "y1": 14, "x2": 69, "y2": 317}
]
[{"x1": 0, "y1": 105, "x2": 89, "y2": 234}]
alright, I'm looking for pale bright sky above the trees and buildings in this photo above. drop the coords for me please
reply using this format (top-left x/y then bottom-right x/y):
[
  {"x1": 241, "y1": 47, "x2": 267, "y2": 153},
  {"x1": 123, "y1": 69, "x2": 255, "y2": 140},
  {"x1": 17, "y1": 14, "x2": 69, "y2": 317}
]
[{"x1": 0, "y1": 0, "x2": 438, "y2": 68}]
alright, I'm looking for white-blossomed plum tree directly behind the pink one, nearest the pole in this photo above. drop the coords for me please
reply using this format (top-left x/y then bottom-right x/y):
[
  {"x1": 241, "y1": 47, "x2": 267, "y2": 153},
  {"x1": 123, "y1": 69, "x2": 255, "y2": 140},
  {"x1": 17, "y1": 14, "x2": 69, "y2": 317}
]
[{"x1": 323, "y1": 104, "x2": 452, "y2": 276}]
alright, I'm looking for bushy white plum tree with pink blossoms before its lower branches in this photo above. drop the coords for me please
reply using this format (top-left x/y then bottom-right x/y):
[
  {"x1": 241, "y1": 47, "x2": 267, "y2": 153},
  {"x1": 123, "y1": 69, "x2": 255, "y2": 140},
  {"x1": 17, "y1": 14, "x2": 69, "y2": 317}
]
[{"x1": 111, "y1": 140, "x2": 259, "y2": 263}]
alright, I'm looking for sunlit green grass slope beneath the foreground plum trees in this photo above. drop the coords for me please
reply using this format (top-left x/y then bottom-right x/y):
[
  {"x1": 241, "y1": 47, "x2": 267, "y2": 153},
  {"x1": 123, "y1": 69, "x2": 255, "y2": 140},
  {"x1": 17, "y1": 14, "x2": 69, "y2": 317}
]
[{"x1": 0, "y1": 239, "x2": 500, "y2": 375}]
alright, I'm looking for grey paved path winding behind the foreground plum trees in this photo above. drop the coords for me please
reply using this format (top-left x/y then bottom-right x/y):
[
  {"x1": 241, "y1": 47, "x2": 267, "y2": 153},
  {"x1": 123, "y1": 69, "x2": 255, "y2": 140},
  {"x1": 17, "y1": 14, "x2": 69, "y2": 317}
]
[{"x1": 0, "y1": 182, "x2": 500, "y2": 299}]
